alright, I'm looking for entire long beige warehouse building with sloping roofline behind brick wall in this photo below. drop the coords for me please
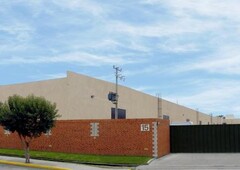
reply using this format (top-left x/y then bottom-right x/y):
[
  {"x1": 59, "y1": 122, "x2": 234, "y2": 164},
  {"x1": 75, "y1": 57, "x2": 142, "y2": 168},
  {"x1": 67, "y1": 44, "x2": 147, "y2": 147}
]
[{"x1": 0, "y1": 72, "x2": 240, "y2": 124}]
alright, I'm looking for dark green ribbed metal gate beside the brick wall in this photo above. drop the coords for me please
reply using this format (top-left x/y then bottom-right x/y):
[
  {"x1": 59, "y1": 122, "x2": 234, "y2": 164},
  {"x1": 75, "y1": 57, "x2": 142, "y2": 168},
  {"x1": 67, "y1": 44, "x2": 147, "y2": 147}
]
[{"x1": 170, "y1": 125, "x2": 240, "y2": 153}]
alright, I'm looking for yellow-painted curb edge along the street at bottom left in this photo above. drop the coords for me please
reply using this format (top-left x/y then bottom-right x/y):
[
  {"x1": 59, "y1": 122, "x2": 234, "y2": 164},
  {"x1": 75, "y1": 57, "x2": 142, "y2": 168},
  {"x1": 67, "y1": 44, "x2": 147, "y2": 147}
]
[{"x1": 0, "y1": 160, "x2": 71, "y2": 170}]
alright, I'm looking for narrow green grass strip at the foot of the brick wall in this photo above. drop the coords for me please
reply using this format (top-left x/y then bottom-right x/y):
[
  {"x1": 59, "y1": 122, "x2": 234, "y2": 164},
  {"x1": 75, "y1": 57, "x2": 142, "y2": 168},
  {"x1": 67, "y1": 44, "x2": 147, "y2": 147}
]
[{"x1": 0, "y1": 149, "x2": 151, "y2": 166}]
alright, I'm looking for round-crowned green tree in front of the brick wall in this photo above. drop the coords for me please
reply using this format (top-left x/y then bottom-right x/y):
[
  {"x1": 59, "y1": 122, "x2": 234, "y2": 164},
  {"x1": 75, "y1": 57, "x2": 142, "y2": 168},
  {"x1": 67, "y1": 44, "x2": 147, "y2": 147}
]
[{"x1": 0, "y1": 95, "x2": 59, "y2": 163}]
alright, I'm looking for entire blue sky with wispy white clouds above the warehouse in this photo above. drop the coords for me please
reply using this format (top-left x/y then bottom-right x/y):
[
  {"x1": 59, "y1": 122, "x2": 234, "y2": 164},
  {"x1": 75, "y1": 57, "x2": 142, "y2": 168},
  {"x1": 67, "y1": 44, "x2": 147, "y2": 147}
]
[{"x1": 0, "y1": 0, "x2": 240, "y2": 118}]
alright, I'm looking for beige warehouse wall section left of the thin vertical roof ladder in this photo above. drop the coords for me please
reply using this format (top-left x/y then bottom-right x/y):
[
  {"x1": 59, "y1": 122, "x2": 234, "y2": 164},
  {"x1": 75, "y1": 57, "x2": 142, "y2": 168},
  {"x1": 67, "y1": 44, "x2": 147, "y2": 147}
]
[{"x1": 0, "y1": 72, "x2": 157, "y2": 120}]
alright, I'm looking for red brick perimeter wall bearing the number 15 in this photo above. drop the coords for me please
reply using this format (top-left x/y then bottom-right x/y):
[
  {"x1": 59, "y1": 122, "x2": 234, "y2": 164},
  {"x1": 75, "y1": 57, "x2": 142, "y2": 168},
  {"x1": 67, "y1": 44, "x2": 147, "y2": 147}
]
[{"x1": 0, "y1": 119, "x2": 170, "y2": 156}]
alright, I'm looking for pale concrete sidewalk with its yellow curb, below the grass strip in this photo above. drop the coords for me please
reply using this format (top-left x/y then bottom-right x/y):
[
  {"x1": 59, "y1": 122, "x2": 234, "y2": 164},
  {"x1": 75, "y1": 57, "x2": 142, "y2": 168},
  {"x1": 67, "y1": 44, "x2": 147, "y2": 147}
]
[{"x1": 0, "y1": 156, "x2": 130, "y2": 170}]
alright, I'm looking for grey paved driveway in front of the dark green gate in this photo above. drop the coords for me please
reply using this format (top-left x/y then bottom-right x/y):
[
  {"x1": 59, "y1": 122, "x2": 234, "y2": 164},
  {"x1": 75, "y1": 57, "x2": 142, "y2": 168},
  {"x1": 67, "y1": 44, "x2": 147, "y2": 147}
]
[{"x1": 136, "y1": 153, "x2": 240, "y2": 170}]
